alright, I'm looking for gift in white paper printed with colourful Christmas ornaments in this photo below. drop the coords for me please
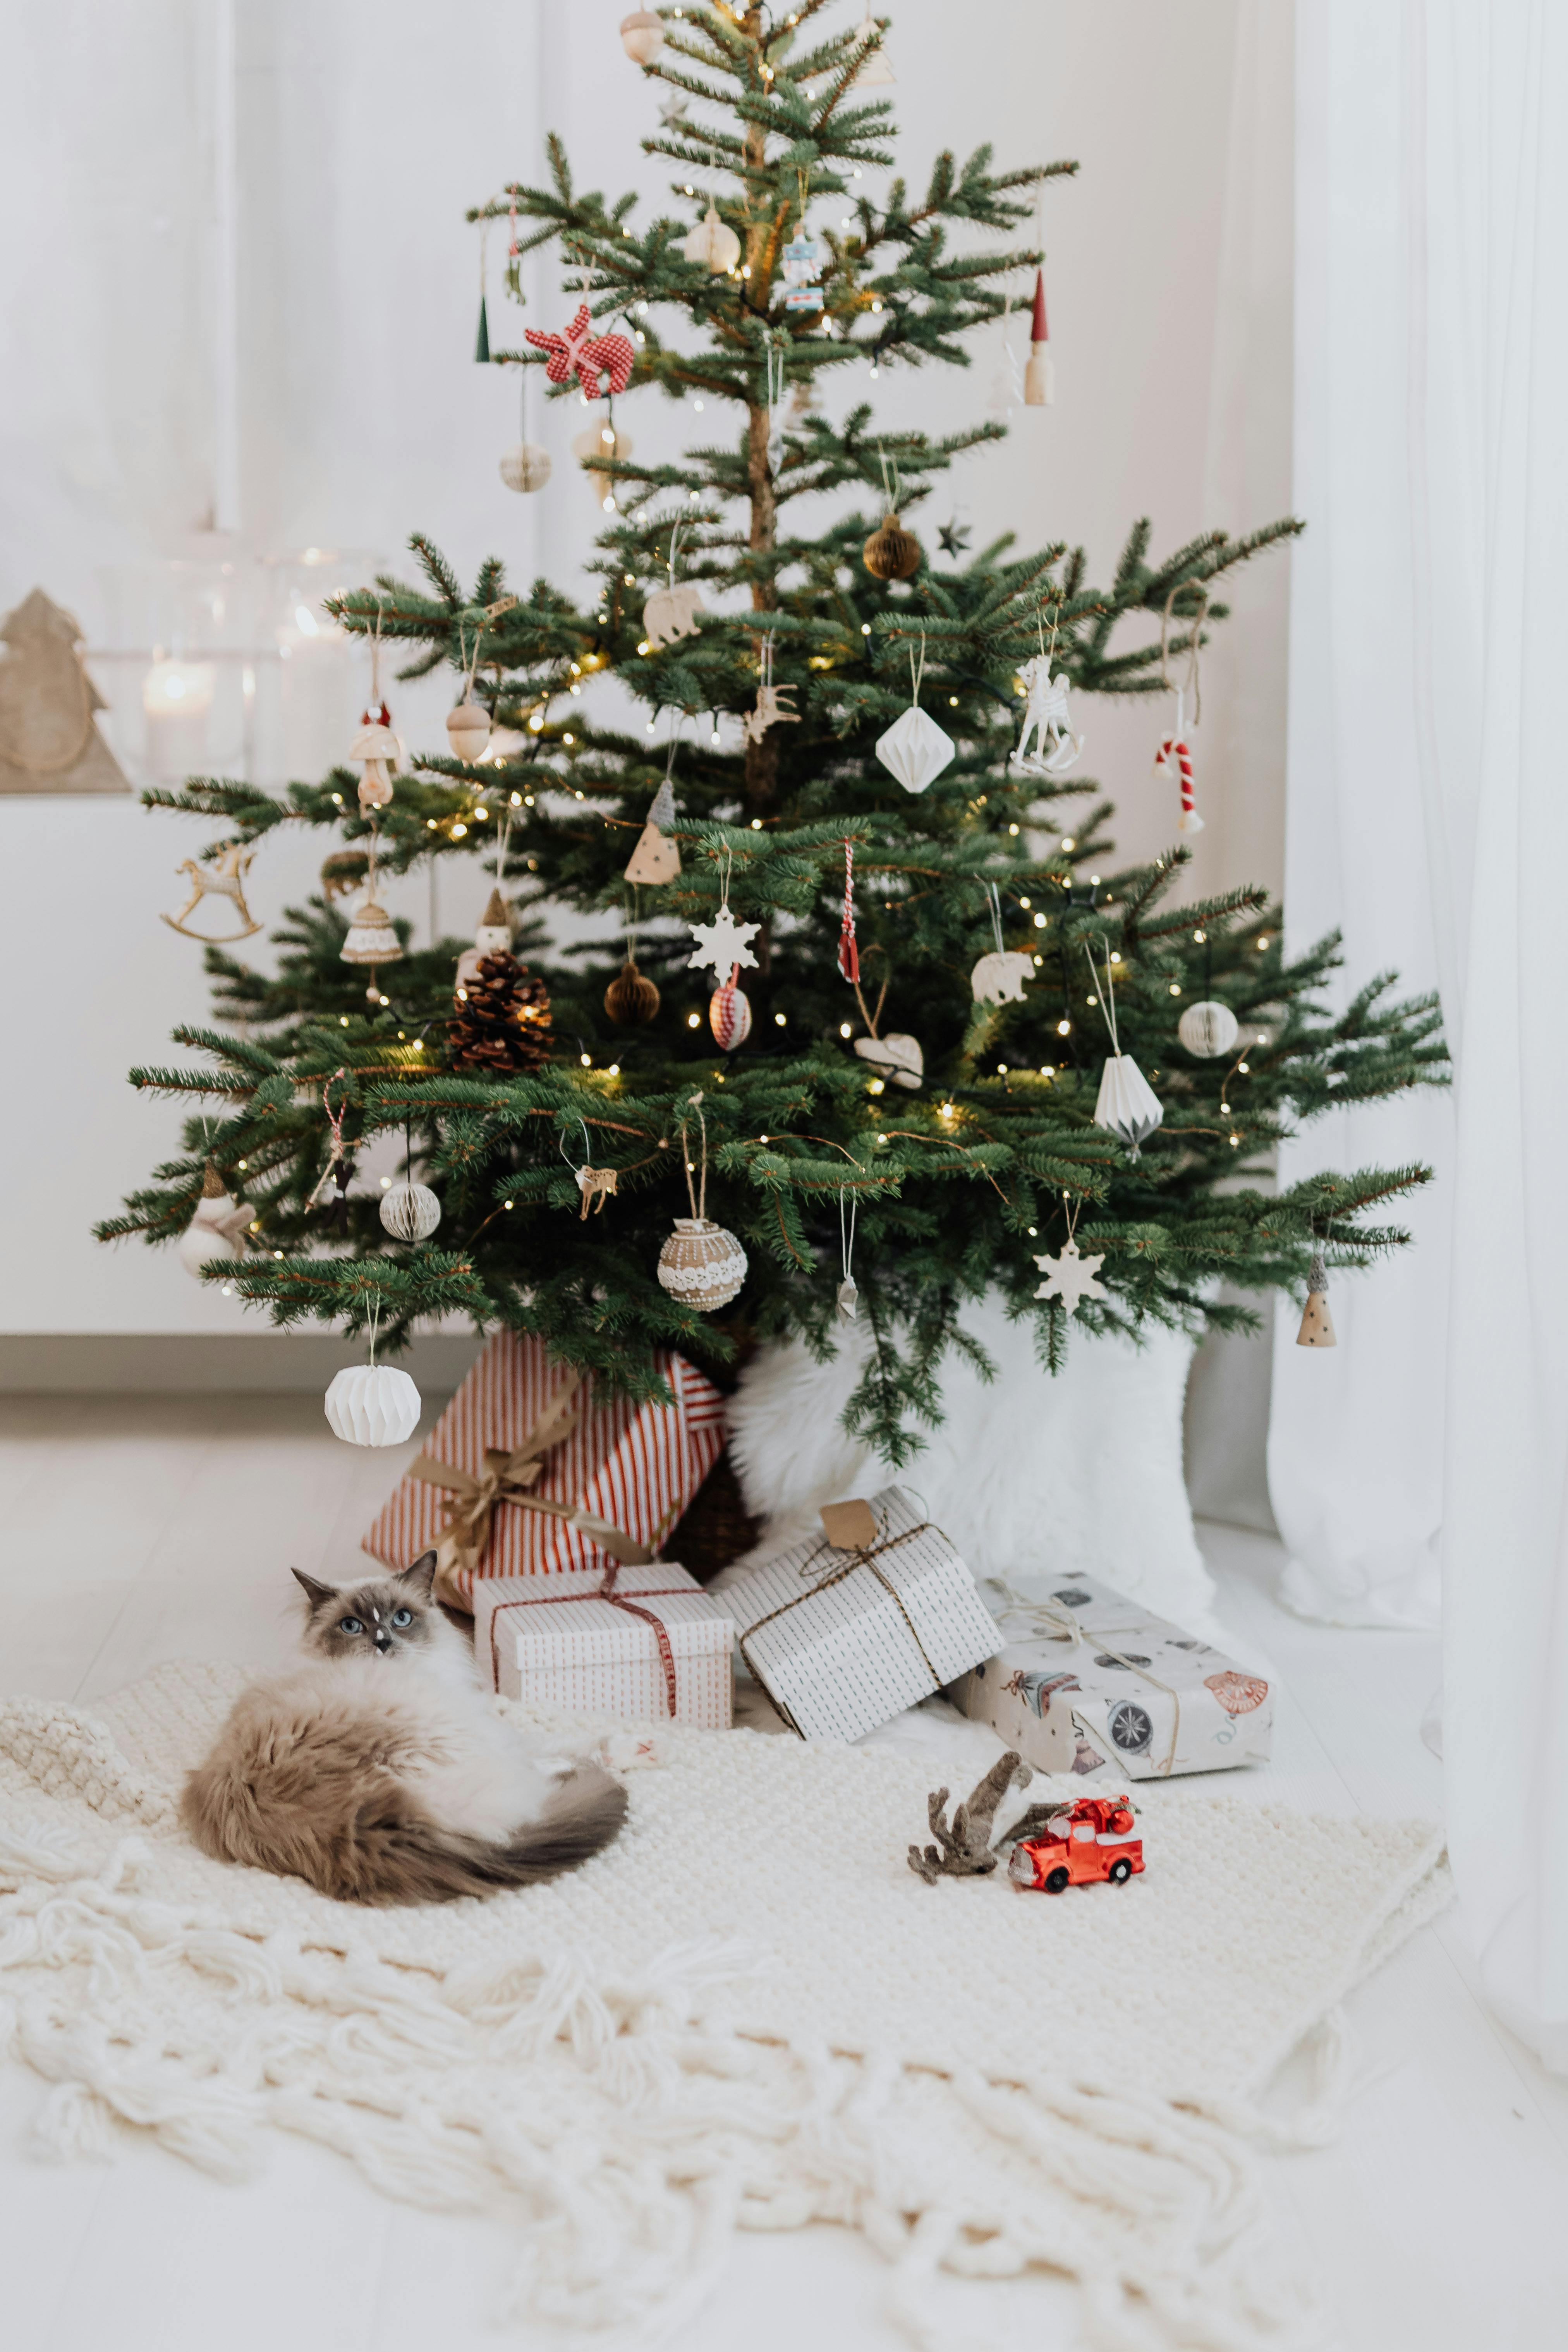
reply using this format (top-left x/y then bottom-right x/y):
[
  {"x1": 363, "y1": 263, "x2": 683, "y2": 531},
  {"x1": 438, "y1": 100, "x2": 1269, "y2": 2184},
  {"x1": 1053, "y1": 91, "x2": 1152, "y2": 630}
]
[{"x1": 950, "y1": 1576, "x2": 1274, "y2": 1780}]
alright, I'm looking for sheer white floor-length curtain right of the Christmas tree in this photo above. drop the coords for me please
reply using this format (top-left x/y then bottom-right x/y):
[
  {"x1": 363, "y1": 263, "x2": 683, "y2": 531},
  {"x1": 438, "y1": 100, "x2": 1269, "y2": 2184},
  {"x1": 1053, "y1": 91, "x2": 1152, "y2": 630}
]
[{"x1": 1269, "y1": 0, "x2": 1568, "y2": 2070}]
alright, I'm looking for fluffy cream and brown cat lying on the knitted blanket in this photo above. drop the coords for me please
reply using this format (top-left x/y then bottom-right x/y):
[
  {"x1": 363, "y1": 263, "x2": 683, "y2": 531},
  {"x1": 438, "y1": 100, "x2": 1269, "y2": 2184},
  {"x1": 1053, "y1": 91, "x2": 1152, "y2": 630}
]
[{"x1": 181, "y1": 1552, "x2": 625, "y2": 1903}]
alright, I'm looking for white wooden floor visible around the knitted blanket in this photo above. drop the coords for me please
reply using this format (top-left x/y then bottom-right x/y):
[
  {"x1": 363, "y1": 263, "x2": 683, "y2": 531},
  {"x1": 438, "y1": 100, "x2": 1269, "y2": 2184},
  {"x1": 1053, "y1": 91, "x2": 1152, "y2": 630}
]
[{"x1": 0, "y1": 1395, "x2": 1568, "y2": 2352}]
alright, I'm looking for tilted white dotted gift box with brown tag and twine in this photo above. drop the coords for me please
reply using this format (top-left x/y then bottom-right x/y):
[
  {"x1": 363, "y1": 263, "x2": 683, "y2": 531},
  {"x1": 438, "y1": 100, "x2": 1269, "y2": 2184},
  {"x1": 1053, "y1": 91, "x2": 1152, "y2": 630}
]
[{"x1": 714, "y1": 1487, "x2": 999, "y2": 1741}]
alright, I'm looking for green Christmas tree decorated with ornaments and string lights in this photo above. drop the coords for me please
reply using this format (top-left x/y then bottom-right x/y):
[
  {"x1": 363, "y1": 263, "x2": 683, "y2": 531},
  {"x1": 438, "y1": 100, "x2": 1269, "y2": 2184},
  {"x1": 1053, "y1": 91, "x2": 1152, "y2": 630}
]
[{"x1": 99, "y1": 0, "x2": 1446, "y2": 1458}]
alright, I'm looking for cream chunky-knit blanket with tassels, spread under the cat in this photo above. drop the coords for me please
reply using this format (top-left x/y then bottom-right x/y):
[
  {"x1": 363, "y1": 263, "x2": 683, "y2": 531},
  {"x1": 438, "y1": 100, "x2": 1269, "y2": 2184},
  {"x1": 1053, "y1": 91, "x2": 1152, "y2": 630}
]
[{"x1": 0, "y1": 1665, "x2": 1446, "y2": 2352}]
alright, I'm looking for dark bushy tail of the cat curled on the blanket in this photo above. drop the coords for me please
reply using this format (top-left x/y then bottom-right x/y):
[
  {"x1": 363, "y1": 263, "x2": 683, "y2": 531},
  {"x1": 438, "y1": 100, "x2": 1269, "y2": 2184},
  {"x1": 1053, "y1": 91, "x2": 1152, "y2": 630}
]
[{"x1": 322, "y1": 1764, "x2": 625, "y2": 1903}]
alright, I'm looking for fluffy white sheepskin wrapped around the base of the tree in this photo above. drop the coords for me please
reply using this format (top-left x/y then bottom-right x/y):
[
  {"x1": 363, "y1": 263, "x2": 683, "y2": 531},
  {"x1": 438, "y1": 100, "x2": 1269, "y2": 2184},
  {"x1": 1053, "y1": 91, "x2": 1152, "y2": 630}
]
[{"x1": 729, "y1": 1301, "x2": 1213, "y2": 1625}]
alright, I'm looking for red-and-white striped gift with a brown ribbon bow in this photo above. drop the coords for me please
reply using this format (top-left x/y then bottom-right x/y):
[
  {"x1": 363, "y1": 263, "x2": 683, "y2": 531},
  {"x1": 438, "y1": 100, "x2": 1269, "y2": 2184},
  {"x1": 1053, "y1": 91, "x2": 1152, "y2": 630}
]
[{"x1": 364, "y1": 1331, "x2": 724, "y2": 1609}]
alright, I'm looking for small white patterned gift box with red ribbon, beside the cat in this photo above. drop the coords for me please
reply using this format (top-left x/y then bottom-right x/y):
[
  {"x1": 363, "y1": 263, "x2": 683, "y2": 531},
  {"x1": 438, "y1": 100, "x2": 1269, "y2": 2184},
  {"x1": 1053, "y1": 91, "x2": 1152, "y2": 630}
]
[{"x1": 475, "y1": 1559, "x2": 736, "y2": 1731}]
